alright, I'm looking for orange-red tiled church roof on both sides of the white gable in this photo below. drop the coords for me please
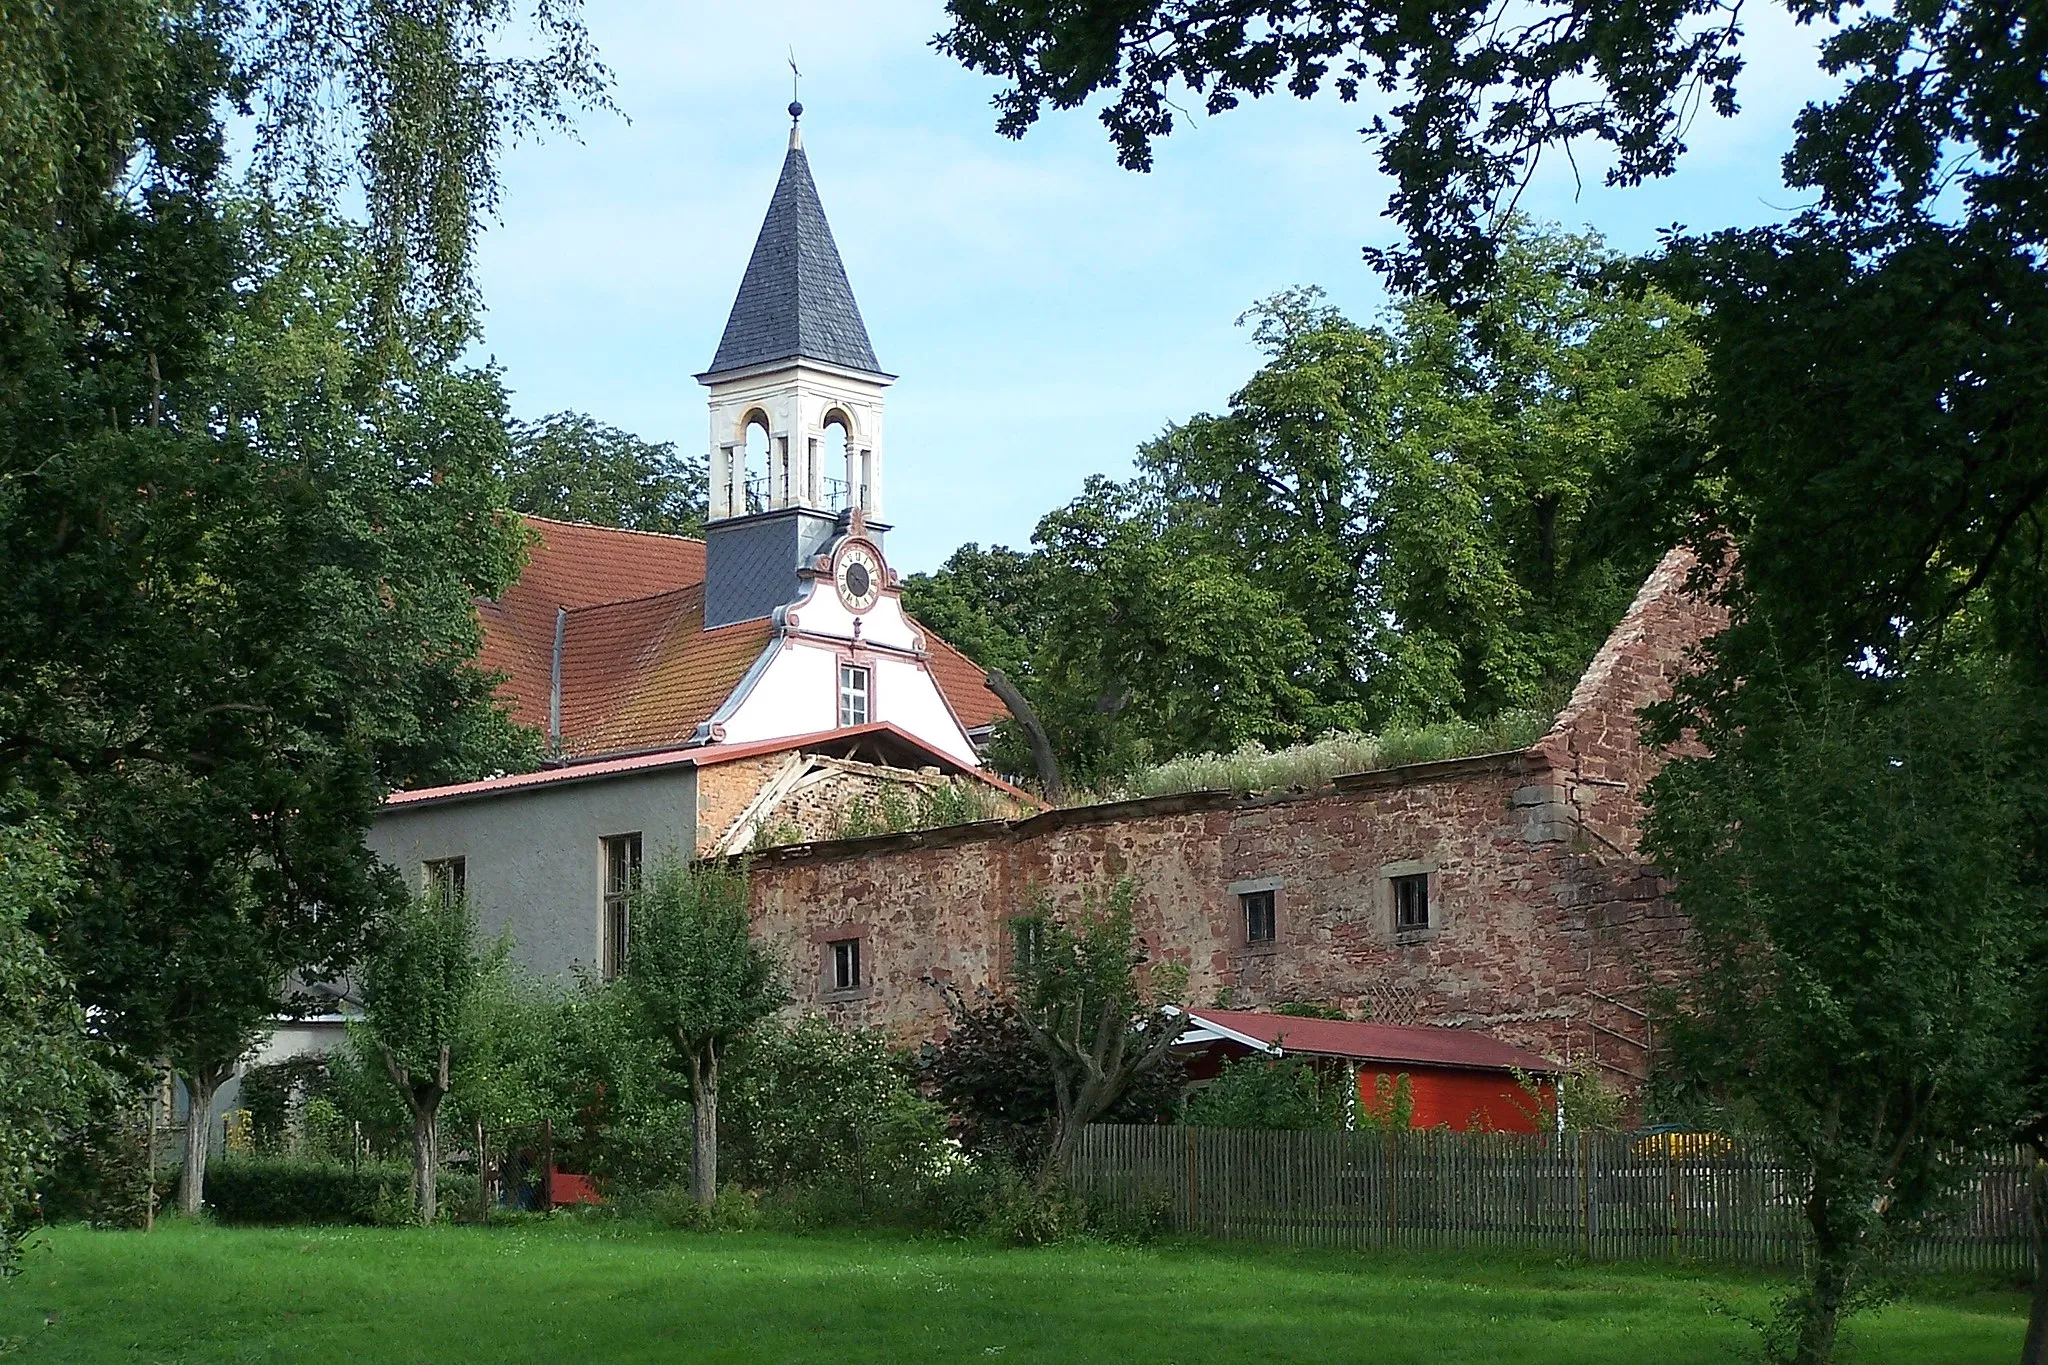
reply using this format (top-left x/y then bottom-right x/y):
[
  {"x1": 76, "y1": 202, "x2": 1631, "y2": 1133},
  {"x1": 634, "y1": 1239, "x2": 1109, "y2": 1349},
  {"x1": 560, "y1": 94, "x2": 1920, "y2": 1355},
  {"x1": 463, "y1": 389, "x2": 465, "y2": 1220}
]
[{"x1": 477, "y1": 516, "x2": 1008, "y2": 755}]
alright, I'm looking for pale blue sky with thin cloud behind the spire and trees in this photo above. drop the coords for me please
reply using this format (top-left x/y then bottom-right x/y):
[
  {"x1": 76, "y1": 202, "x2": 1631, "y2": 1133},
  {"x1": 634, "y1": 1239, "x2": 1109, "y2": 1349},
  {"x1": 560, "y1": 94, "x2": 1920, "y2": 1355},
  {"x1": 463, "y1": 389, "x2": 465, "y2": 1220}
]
[{"x1": 477, "y1": 0, "x2": 1829, "y2": 573}]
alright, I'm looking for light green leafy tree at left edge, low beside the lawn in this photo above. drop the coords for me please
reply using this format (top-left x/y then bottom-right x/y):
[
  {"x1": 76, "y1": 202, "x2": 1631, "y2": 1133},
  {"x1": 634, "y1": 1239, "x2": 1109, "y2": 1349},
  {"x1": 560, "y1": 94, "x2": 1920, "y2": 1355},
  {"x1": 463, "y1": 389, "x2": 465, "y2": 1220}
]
[{"x1": 0, "y1": 810, "x2": 104, "y2": 1277}]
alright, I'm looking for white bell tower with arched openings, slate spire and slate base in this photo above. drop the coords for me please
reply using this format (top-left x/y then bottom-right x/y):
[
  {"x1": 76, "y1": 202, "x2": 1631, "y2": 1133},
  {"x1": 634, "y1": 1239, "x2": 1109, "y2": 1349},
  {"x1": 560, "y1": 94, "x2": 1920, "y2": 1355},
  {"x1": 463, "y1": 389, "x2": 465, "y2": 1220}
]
[{"x1": 696, "y1": 102, "x2": 895, "y2": 630}]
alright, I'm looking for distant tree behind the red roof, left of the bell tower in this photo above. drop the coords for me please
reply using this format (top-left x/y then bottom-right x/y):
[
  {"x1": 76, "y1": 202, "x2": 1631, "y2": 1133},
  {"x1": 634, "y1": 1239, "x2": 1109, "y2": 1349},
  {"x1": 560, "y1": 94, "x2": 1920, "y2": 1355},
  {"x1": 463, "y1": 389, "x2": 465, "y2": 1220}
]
[{"x1": 500, "y1": 411, "x2": 711, "y2": 536}]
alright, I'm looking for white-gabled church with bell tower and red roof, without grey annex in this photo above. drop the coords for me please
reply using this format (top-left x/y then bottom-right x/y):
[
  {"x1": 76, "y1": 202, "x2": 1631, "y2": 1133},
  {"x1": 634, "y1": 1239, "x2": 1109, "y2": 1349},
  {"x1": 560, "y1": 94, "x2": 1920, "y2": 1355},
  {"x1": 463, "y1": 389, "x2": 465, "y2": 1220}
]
[{"x1": 466, "y1": 104, "x2": 1006, "y2": 767}]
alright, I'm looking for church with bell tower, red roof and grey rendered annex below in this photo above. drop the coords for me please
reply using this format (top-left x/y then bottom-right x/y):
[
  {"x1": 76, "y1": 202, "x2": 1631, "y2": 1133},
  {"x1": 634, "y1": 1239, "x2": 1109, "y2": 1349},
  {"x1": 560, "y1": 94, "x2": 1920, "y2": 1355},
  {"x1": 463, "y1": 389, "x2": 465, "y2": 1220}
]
[{"x1": 369, "y1": 104, "x2": 1040, "y2": 976}]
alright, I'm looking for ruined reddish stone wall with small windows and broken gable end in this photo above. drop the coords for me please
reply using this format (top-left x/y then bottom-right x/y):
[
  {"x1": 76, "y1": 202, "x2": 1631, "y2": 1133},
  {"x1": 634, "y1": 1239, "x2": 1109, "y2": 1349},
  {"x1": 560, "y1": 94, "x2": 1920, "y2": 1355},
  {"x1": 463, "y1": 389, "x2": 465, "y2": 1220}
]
[{"x1": 754, "y1": 551, "x2": 1720, "y2": 1085}]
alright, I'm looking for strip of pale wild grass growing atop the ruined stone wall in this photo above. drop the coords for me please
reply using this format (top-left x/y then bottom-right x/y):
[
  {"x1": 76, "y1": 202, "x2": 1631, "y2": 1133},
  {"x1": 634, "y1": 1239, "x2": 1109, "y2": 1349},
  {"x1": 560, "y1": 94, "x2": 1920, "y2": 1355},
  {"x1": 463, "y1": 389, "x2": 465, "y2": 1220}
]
[{"x1": 1087, "y1": 710, "x2": 1554, "y2": 800}]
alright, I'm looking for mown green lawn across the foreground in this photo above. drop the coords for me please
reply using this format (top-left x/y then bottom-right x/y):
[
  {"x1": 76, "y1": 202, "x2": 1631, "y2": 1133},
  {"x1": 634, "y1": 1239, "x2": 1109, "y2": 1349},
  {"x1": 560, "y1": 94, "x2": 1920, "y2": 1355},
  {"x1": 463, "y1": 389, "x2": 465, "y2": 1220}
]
[{"x1": 0, "y1": 1220, "x2": 2025, "y2": 1365}]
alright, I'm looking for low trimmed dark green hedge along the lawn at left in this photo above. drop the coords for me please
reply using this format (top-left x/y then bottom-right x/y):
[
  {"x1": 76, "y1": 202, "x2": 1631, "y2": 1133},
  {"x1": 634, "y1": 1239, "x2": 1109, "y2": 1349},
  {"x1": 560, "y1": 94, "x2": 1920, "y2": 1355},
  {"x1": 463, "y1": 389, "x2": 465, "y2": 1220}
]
[{"x1": 207, "y1": 1156, "x2": 479, "y2": 1226}]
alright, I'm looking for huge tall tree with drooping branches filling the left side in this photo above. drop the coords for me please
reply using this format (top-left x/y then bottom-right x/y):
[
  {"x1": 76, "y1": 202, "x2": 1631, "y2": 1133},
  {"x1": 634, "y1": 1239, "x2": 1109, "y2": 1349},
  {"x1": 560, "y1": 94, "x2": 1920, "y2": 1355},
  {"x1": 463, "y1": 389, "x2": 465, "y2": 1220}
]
[{"x1": 0, "y1": 0, "x2": 600, "y2": 1207}]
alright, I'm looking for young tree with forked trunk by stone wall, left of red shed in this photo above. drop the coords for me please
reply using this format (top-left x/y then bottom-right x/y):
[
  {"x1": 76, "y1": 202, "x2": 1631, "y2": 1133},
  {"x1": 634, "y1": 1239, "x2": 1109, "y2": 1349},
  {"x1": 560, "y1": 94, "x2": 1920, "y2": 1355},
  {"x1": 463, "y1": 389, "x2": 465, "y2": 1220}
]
[{"x1": 1016, "y1": 878, "x2": 1188, "y2": 1187}]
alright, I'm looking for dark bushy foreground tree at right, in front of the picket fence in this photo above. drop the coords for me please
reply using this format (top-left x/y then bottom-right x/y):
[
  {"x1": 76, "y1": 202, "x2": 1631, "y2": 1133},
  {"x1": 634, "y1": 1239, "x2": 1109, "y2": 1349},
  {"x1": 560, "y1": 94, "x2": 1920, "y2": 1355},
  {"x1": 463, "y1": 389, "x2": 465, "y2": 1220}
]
[{"x1": 1647, "y1": 659, "x2": 2048, "y2": 1363}]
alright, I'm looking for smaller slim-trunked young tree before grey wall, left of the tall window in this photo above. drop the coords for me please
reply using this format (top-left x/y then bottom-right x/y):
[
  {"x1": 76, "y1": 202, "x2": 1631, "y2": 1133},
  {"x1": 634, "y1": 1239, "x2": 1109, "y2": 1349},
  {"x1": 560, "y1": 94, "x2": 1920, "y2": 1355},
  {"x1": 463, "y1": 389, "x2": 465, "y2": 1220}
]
[{"x1": 360, "y1": 892, "x2": 491, "y2": 1226}]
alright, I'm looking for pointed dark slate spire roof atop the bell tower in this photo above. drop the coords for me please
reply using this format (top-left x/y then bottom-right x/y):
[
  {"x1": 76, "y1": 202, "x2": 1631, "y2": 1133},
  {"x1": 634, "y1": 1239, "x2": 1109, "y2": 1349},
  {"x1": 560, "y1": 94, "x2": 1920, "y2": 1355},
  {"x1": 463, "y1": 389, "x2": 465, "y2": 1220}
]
[{"x1": 702, "y1": 147, "x2": 883, "y2": 377}]
